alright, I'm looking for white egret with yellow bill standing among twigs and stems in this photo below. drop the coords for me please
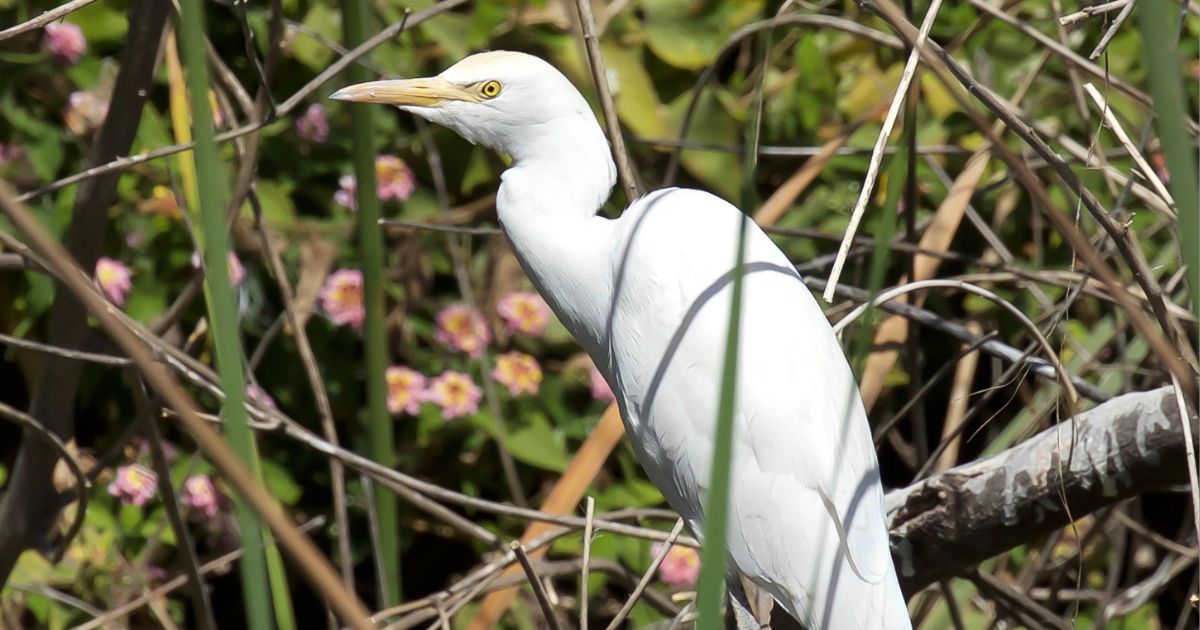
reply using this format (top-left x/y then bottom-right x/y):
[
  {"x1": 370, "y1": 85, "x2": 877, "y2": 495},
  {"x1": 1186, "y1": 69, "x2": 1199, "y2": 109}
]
[{"x1": 332, "y1": 52, "x2": 911, "y2": 630}]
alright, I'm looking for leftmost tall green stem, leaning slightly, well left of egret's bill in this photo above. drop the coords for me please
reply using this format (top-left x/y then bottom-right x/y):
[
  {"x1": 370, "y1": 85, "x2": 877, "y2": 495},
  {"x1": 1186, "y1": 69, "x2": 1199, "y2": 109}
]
[{"x1": 172, "y1": 0, "x2": 271, "y2": 630}]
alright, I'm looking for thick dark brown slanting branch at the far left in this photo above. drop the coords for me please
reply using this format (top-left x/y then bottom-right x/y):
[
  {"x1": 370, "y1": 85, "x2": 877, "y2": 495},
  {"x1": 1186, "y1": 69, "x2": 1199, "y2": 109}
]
[{"x1": 0, "y1": 0, "x2": 170, "y2": 584}]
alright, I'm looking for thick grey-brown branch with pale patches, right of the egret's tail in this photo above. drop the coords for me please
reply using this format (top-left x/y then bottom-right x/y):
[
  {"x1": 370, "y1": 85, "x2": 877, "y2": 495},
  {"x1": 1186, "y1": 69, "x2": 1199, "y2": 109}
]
[{"x1": 884, "y1": 388, "x2": 1198, "y2": 594}]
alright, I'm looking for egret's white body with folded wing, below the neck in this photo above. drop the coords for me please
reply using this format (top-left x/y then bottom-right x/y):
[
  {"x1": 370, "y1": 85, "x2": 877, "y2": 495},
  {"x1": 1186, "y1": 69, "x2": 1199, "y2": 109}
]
[{"x1": 601, "y1": 190, "x2": 911, "y2": 630}]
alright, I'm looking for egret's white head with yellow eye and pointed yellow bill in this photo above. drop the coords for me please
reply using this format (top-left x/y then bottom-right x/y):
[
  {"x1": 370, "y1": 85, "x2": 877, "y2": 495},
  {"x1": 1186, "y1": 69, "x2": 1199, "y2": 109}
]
[{"x1": 330, "y1": 50, "x2": 599, "y2": 160}]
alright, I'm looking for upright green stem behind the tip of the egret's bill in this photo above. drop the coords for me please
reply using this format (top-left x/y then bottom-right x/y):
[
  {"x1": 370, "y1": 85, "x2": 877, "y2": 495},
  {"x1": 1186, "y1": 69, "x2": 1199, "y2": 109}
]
[{"x1": 342, "y1": 0, "x2": 401, "y2": 607}]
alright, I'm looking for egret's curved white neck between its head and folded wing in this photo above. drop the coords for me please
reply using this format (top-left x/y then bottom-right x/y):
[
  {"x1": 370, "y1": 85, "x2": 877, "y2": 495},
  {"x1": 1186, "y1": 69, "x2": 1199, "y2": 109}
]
[{"x1": 496, "y1": 112, "x2": 616, "y2": 360}]
